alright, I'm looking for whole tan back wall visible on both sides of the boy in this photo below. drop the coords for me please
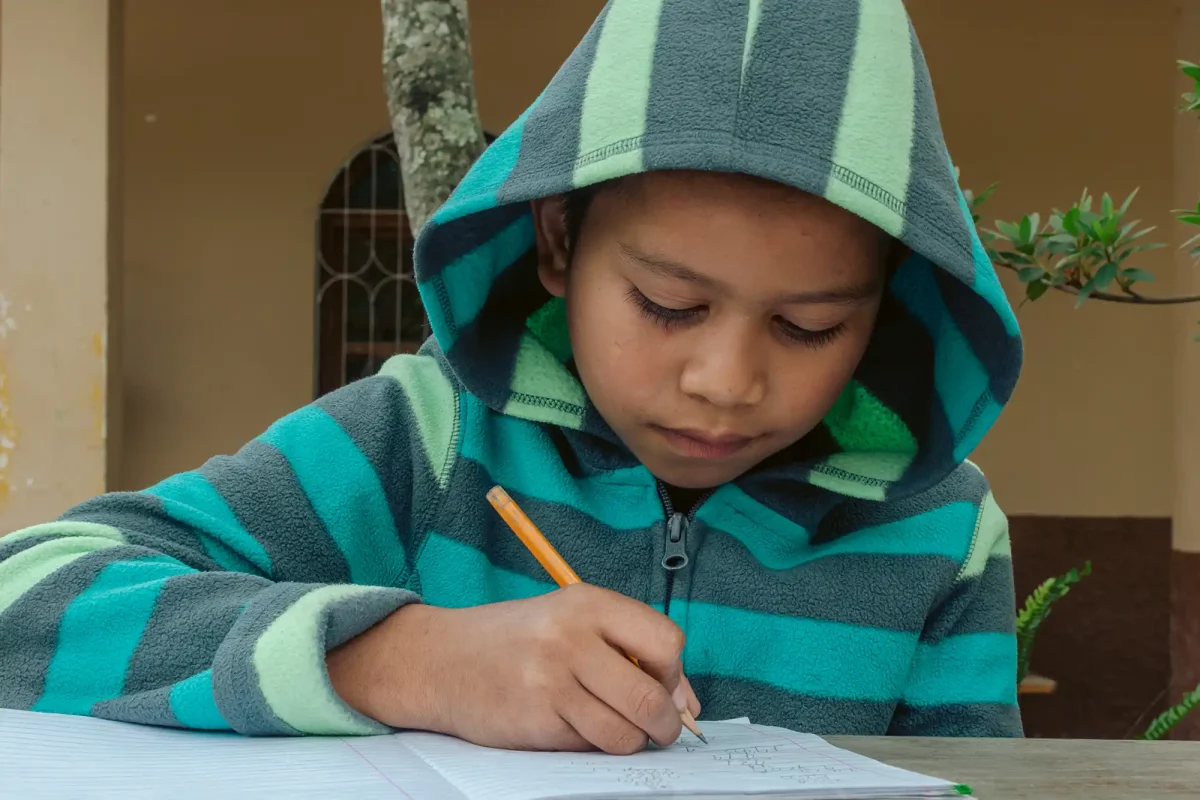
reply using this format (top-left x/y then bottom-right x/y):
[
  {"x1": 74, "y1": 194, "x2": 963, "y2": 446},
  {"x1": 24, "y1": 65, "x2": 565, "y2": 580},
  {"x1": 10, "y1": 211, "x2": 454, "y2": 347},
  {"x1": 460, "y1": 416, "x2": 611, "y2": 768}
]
[{"x1": 121, "y1": 0, "x2": 1176, "y2": 516}]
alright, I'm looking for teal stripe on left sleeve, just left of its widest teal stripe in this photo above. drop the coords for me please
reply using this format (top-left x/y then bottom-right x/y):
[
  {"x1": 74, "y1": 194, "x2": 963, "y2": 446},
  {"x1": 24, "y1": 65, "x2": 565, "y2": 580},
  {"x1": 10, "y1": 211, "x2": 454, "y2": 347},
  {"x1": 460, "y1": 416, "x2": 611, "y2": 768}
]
[{"x1": 145, "y1": 473, "x2": 274, "y2": 577}]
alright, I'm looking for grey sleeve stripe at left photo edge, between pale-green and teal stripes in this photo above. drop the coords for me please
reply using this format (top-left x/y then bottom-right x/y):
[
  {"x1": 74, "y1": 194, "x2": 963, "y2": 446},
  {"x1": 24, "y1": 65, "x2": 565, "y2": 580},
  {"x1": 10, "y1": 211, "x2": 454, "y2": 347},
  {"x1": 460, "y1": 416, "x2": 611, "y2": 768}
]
[{"x1": 0, "y1": 547, "x2": 157, "y2": 709}]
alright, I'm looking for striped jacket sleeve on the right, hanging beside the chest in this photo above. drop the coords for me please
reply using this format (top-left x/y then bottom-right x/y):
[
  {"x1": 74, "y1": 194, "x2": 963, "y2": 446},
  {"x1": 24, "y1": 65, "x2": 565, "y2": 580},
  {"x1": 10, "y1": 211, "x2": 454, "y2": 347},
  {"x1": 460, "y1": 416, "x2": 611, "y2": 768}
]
[{"x1": 888, "y1": 492, "x2": 1022, "y2": 736}]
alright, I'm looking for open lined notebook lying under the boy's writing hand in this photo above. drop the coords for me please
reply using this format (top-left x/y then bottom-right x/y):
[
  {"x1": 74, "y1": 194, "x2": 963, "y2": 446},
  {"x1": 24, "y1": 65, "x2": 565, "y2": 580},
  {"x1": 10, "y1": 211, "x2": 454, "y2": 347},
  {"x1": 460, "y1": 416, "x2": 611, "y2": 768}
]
[{"x1": 0, "y1": 710, "x2": 959, "y2": 800}]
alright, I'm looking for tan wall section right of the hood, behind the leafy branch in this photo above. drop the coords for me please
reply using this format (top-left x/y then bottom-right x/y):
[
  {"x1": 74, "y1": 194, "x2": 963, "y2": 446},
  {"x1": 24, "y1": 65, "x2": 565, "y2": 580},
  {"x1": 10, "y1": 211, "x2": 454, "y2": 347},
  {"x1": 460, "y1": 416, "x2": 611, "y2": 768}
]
[{"x1": 908, "y1": 0, "x2": 1171, "y2": 516}]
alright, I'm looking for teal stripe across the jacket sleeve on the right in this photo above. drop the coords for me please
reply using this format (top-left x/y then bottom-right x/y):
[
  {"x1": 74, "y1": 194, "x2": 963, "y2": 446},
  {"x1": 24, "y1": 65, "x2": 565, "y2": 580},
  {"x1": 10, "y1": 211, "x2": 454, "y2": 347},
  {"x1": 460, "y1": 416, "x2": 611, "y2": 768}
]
[{"x1": 904, "y1": 633, "x2": 1016, "y2": 705}]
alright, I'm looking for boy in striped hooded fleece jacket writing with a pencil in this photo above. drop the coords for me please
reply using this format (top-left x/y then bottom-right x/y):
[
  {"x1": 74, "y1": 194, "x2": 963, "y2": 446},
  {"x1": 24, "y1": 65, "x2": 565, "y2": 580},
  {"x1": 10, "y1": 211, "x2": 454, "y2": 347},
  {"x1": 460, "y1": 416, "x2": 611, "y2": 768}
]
[{"x1": 0, "y1": 0, "x2": 1021, "y2": 753}]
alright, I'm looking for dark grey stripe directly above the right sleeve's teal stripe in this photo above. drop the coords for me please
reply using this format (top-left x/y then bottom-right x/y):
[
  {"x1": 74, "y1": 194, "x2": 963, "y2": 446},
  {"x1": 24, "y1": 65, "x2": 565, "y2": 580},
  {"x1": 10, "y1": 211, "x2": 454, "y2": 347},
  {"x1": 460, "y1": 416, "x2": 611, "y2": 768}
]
[{"x1": 920, "y1": 557, "x2": 1016, "y2": 644}]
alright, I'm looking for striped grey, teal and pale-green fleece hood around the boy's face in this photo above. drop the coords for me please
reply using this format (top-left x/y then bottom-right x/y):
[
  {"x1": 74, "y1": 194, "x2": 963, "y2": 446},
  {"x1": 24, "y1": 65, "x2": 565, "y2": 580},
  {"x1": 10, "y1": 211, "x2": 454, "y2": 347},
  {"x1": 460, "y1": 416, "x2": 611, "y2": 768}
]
[{"x1": 415, "y1": 0, "x2": 1021, "y2": 500}]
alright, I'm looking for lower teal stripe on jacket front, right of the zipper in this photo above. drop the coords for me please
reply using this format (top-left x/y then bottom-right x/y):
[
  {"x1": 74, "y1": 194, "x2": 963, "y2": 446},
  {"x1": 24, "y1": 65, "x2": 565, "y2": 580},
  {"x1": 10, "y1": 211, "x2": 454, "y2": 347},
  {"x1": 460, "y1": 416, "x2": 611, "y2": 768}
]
[{"x1": 686, "y1": 602, "x2": 919, "y2": 700}]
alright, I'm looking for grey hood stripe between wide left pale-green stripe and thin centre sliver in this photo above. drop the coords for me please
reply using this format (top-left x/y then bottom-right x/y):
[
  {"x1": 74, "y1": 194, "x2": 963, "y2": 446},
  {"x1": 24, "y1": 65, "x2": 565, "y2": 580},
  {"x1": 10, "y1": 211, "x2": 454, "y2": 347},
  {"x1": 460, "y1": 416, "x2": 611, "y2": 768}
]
[{"x1": 642, "y1": 0, "x2": 750, "y2": 169}]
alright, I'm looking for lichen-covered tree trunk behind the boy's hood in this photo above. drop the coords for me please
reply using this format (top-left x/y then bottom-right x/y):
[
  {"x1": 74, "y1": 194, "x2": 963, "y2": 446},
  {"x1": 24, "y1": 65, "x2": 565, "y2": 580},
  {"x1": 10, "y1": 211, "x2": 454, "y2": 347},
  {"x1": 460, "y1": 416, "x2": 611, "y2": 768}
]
[{"x1": 382, "y1": 0, "x2": 485, "y2": 234}]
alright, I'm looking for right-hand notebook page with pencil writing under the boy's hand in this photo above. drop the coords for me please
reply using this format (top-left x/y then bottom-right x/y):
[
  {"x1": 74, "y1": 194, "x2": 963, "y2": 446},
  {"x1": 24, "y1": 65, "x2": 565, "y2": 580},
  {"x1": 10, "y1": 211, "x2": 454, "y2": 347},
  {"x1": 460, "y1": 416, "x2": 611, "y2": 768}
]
[{"x1": 404, "y1": 722, "x2": 956, "y2": 800}]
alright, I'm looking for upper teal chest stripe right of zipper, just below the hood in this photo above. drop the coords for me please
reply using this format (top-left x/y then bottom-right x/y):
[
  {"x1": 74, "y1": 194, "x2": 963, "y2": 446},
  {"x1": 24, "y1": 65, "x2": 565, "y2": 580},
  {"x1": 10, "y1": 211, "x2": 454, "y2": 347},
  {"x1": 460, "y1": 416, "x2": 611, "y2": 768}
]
[{"x1": 696, "y1": 486, "x2": 979, "y2": 570}]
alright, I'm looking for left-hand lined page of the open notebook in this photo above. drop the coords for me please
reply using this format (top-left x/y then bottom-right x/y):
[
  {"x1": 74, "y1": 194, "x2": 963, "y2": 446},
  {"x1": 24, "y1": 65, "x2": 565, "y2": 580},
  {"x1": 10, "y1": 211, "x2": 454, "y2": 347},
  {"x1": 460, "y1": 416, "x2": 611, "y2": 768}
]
[{"x1": 0, "y1": 709, "x2": 462, "y2": 800}]
